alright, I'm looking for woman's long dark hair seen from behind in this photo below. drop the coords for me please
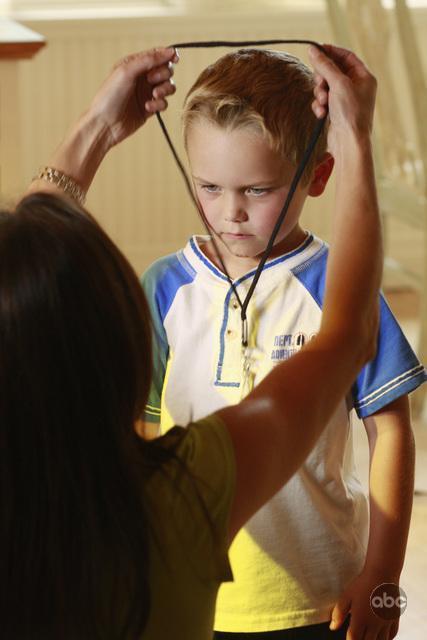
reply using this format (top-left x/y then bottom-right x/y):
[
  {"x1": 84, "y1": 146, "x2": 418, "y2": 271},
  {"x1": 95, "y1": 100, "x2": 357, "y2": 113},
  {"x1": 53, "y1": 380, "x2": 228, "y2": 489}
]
[{"x1": 0, "y1": 194, "x2": 157, "y2": 640}]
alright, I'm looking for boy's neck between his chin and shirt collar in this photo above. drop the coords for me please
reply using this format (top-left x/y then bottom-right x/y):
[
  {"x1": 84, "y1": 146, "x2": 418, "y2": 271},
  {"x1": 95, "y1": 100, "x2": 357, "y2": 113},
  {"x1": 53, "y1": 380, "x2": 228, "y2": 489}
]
[{"x1": 200, "y1": 225, "x2": 307, "y2": 281}]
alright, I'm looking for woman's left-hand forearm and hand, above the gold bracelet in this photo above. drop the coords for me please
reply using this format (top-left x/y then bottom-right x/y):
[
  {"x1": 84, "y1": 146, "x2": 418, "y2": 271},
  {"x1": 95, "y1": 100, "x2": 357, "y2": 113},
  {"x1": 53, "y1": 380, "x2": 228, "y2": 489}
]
[{"x1": 29, "y1": 48, "x2": 178, "y2": 195}]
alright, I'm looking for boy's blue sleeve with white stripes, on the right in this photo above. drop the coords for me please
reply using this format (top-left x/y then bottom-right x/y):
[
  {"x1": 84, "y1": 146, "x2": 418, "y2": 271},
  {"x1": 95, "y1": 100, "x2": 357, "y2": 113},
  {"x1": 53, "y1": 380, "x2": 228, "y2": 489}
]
[{"x1": 352, "y1": 296, "x2": 427, "y2": 418}]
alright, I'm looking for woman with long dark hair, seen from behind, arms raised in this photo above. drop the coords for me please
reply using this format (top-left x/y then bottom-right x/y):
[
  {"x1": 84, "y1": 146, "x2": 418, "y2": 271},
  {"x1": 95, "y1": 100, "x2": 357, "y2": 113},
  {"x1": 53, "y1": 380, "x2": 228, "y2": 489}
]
[{"x1": 0, "y1": 47, "x2": 381, "y2": 640}]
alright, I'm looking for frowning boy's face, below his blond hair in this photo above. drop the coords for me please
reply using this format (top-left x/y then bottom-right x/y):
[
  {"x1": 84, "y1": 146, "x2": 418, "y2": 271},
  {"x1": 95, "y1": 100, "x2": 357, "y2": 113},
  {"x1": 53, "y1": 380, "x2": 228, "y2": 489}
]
[{"x1": 187, "y1": 119, "x2": 308, "y2": 259}]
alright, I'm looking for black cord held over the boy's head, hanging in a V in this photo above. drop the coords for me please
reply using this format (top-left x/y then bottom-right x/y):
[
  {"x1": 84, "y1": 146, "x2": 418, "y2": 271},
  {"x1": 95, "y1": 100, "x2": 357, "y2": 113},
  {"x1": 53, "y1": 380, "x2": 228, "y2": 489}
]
[{"x1": 156, "y1": 40, "x2": 327, "y2": 347}]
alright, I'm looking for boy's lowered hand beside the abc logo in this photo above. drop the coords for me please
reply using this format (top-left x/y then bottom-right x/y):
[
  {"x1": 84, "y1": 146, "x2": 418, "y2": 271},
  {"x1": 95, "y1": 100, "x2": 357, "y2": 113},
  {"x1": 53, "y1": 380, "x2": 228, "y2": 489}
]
[{"x1": 330, "y1": 571, "x2": 399, "y2": 640}]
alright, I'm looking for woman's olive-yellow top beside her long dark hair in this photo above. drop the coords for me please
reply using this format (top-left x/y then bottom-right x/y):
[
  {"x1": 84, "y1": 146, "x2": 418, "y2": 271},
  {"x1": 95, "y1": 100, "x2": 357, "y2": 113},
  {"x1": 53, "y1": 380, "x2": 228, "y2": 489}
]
[{"x1": 144, "y1": 416, "x2": 235, "y2": 640}]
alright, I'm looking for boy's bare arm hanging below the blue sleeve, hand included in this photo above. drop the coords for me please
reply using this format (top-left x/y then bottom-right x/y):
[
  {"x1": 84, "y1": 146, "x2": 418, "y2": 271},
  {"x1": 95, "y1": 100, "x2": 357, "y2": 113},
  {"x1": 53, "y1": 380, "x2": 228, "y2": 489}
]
[{"x1": 331, "y1": 395, "x2": 415, "y2": 640}]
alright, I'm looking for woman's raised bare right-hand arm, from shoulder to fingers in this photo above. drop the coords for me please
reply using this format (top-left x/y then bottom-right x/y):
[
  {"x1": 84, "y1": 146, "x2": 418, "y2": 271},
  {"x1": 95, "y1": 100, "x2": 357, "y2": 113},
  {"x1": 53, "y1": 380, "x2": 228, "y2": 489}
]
[{"x1": 222, "y1": 46, "x2": 382, "y2": 539}]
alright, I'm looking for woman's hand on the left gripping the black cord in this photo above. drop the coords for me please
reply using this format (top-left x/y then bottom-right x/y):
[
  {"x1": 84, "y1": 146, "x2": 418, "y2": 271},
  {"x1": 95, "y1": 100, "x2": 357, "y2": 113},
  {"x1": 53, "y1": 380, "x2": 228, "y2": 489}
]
[{"x1": 89, "y1": 48, "x2": 178, "y2": 147}]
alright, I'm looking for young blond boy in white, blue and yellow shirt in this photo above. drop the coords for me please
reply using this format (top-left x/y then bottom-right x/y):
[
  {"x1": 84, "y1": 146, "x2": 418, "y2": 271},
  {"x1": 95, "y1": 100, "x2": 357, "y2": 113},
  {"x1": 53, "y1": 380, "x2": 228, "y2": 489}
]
[{"x1": 143, "y1": 50, "x2": 427, "y2": 640}]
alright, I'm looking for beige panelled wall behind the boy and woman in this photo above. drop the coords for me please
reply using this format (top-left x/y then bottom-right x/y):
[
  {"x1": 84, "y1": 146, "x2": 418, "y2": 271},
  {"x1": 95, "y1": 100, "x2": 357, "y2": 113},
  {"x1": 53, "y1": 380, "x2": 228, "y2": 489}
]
[{"x1": 0, "y1": 6, "x2": 427, "y2": 282}]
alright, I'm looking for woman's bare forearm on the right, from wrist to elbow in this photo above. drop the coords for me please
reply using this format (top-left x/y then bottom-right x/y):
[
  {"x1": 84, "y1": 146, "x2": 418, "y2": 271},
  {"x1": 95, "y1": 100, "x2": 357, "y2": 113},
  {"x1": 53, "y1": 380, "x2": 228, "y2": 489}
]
[{"x1": 322, "y1": 132, "x2": 383, "y2": 338}]
